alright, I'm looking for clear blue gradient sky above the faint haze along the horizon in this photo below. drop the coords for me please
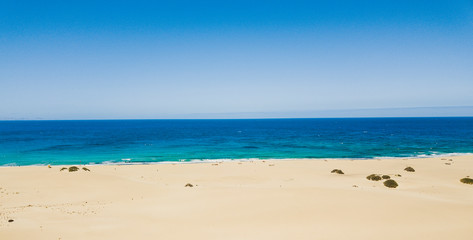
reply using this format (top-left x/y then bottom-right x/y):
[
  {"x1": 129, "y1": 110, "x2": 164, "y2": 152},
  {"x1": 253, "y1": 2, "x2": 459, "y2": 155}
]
[{"x1": 0, "y1": 0, "x2": 473, "y2": 119}]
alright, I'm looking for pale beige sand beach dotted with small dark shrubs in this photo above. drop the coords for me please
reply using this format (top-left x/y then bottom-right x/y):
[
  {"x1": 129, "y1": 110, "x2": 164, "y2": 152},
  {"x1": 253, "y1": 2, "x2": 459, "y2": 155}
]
[{"x1": 0, "y1": 156, "x2": 473, "y2": 240}]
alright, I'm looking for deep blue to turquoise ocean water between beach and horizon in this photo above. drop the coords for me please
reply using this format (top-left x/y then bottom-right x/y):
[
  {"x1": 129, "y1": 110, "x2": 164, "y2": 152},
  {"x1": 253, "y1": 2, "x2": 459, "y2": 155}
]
[{"x1": 0, "y1": 118, "x2": 473, "y2": 165}]
